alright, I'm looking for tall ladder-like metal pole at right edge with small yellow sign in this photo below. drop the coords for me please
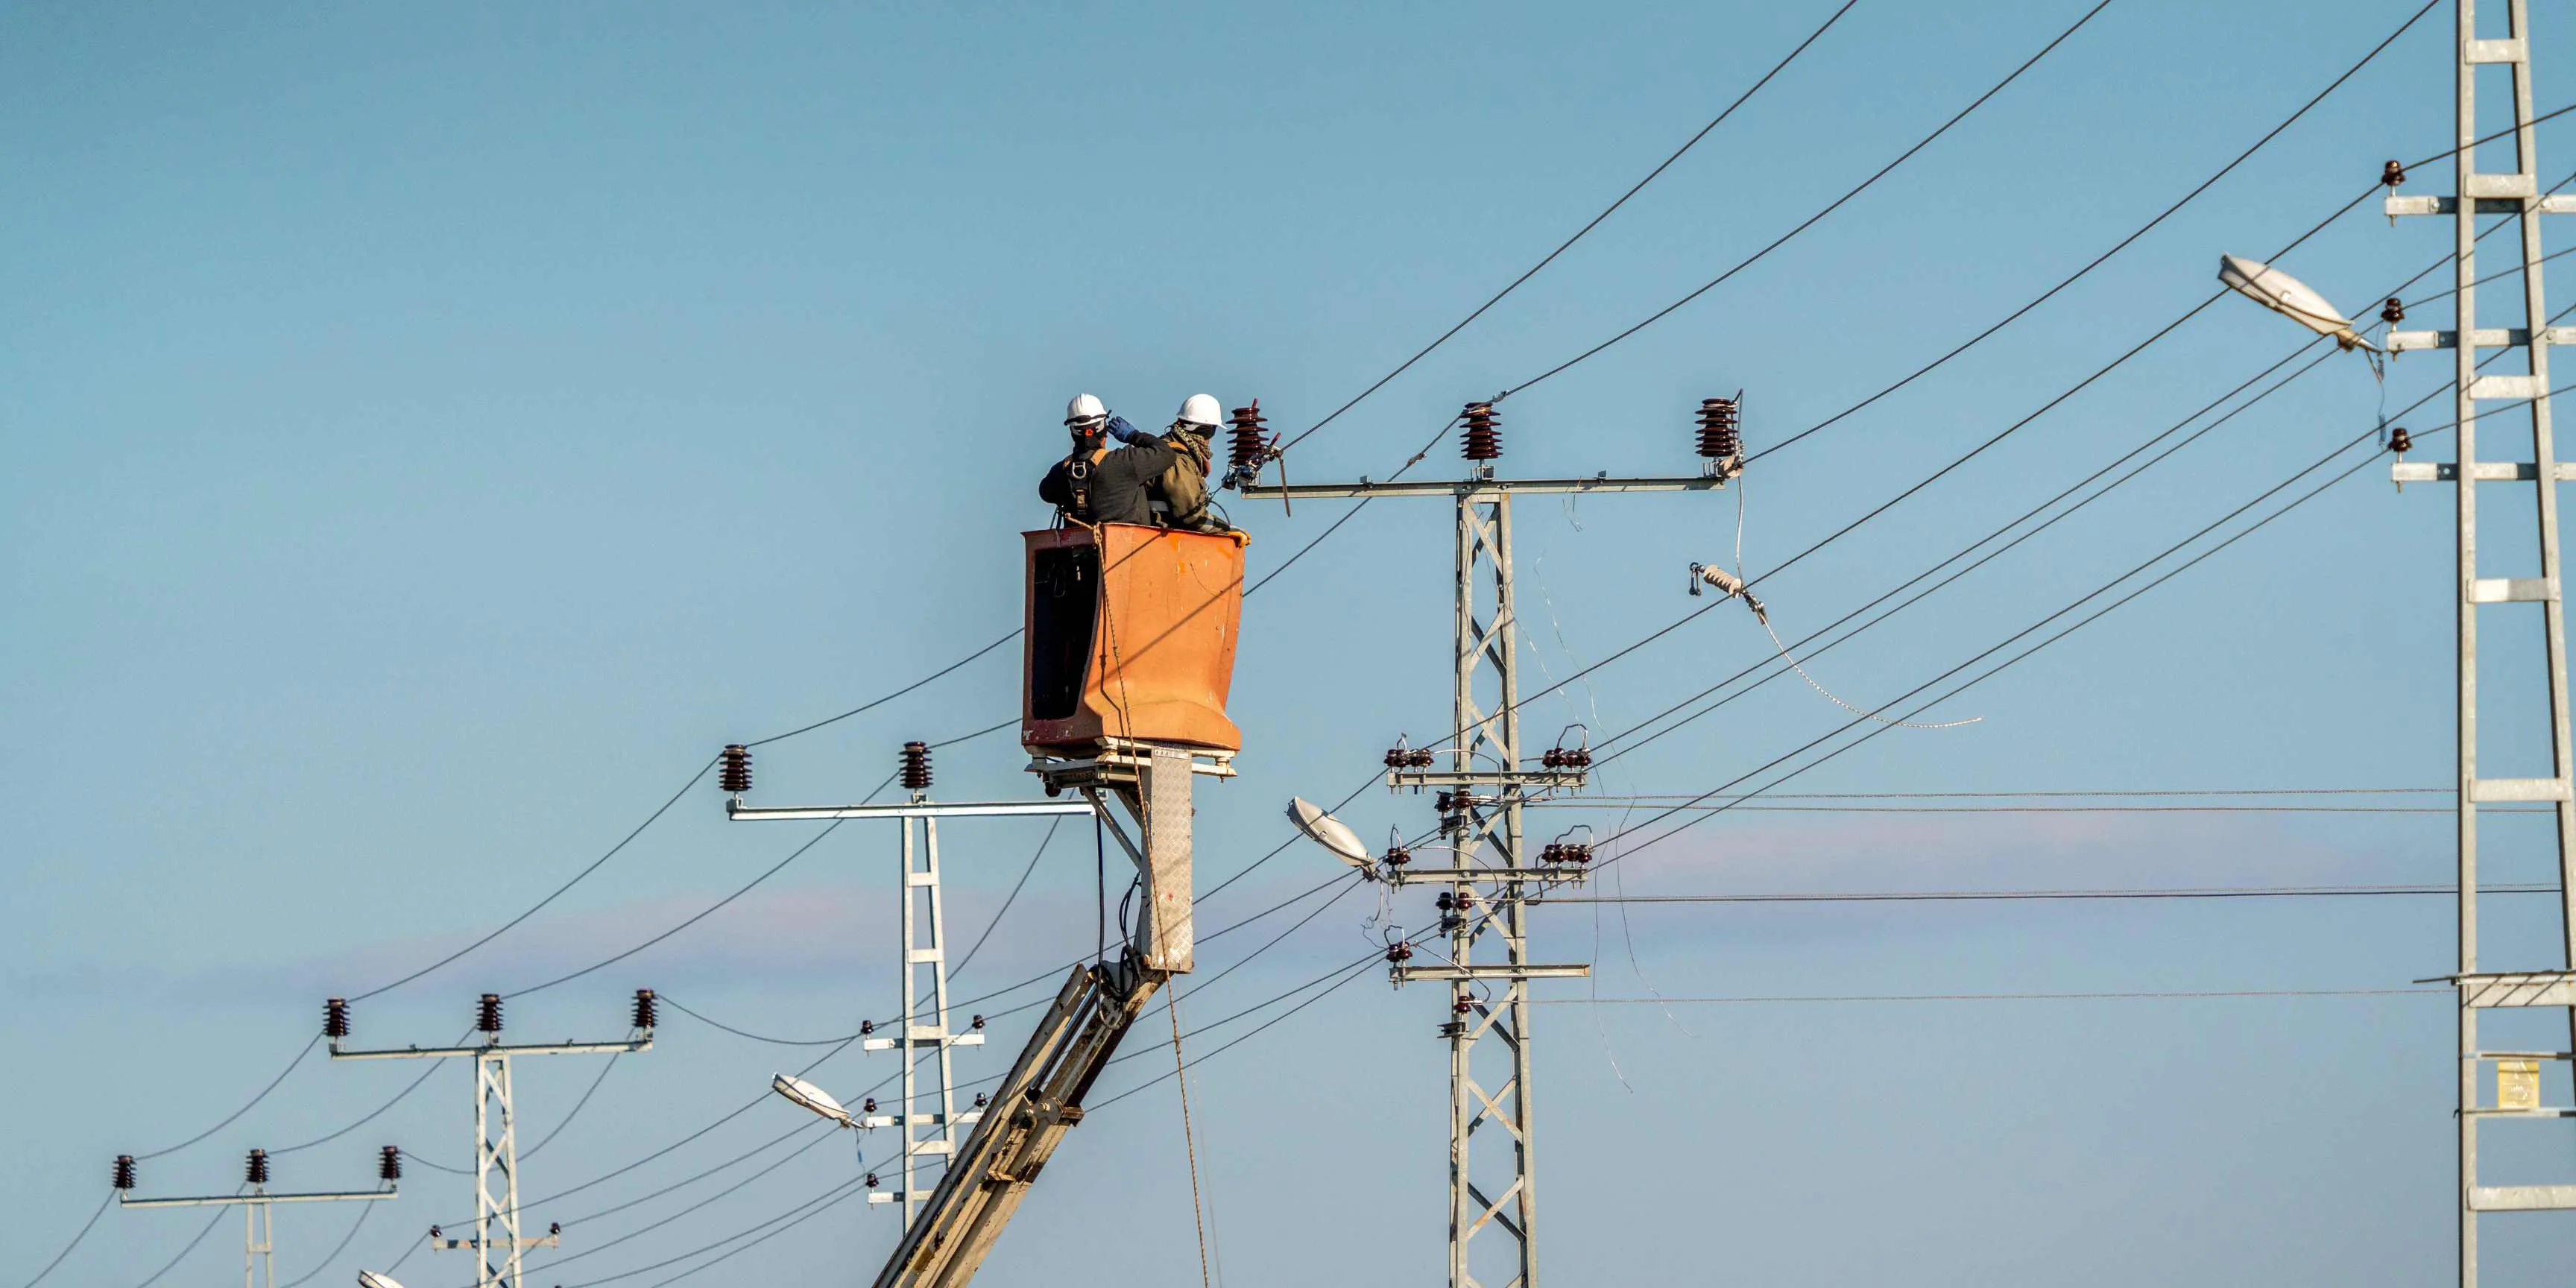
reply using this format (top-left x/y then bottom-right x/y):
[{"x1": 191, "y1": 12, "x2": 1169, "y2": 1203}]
[{"x1": 2385, "y1": 0, "x2": 2576, "y2": 1288}]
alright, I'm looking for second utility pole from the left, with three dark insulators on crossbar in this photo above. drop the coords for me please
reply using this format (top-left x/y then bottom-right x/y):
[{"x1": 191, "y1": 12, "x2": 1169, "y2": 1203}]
[{"x1": 322, "y1": 989, "x2": 654, "y2": 1288}]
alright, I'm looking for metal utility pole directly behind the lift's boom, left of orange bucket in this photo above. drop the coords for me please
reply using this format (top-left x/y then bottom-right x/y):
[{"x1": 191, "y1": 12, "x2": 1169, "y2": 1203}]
[{"x1": 719, "y1": 742, "x2": 1092, "y2": 1229}]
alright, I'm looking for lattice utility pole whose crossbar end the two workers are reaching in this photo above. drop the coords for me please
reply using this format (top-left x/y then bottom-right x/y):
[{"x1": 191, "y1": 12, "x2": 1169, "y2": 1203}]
[{"x1": 1234, "y1": 400, "x2": 1741, "y2": 1288}]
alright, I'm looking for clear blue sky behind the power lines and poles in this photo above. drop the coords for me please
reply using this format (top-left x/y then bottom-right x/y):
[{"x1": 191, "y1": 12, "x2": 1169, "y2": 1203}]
[{"x1": 0, "y1": 0, "x2": 2576, "y2": 1288}]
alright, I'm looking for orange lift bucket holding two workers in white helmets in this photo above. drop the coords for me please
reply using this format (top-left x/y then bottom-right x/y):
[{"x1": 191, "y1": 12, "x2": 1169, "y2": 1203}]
[{"x1": 1020, "y1": 523, "x2": 1249, "y2": 755}]
